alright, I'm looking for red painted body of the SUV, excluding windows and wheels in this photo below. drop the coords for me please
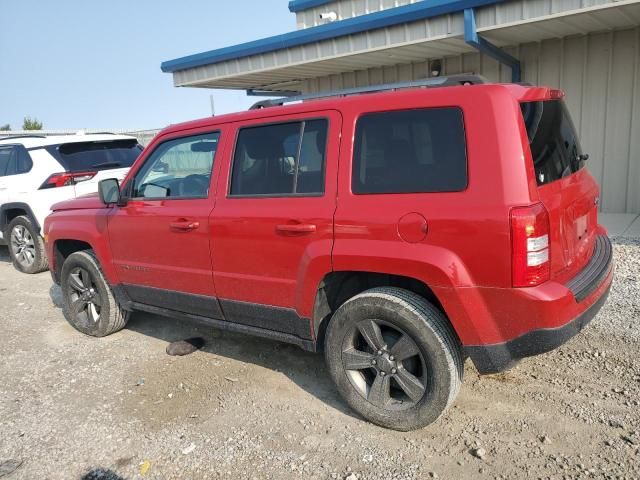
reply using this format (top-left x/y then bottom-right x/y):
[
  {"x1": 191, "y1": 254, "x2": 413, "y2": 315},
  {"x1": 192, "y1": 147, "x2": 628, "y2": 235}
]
[{"x1": 45, "y1": 85, "x2": 612, "y2": 352}]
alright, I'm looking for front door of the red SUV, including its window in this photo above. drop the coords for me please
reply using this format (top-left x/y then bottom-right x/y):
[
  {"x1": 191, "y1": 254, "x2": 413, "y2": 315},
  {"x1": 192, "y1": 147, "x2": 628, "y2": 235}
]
[{"x1": 109, "y1": 132, "x2": 226, "y2": 318}]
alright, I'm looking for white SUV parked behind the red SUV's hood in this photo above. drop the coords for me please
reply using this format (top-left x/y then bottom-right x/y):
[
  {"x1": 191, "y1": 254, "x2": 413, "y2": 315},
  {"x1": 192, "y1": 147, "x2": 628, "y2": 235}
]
[{"x1": 0, "y1": 134, "x2": 142, "y2": 273}]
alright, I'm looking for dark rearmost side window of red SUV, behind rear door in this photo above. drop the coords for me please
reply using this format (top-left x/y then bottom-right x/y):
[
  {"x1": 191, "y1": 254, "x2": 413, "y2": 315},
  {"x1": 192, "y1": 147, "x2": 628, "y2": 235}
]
[{"x1": 351, "y1": 107, "x2": 467, "y2": 194}]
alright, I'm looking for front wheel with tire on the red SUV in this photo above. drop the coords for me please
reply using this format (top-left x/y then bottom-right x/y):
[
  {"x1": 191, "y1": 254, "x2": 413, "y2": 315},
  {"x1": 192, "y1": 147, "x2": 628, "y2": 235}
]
[{"x1": 60, "y1": 250, "x2": 129, "y2": 337}]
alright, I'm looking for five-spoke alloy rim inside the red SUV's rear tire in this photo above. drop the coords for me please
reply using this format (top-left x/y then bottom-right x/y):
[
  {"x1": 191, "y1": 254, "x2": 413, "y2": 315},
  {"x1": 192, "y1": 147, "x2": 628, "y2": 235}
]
[{"x1": 342, "y1": 319, "x2": 429, "y2": 410}]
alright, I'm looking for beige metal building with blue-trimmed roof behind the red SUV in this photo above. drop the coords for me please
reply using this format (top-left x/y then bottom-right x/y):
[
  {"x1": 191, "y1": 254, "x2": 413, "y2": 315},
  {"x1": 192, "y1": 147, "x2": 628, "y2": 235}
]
[{"x1": 162, "y1": 0, "x2": 640, "y2": 213}]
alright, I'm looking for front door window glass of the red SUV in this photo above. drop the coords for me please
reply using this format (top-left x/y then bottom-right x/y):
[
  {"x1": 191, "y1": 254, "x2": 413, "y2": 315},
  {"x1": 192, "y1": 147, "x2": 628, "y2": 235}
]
[{"x1": 131, "y1": 132, "x2": 220, "y2": 199}]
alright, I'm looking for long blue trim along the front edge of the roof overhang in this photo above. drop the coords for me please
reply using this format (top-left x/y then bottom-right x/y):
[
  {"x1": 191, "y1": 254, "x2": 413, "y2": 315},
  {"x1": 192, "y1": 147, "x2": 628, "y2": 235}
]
[{"x1": 160, "y1": 0, "x2": 505, "y2": 72}]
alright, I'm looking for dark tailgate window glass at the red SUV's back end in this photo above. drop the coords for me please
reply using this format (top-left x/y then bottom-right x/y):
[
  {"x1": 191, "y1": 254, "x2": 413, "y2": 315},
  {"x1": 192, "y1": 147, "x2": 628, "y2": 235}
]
[{"x1": 520, "y1": 100, "x2": 584, "y2": 185}]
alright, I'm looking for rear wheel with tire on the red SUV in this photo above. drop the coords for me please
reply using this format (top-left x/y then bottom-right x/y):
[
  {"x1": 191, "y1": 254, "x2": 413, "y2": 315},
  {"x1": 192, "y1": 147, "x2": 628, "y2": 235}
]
[{"x1": 325, "y1": 287, "x2": 463, "y2": 431}]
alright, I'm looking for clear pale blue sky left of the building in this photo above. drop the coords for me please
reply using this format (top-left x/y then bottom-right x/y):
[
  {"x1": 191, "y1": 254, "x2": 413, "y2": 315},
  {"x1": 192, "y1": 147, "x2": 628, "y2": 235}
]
[{"x1": 0, "y1": 0, "x2": 295, "y2": 130}]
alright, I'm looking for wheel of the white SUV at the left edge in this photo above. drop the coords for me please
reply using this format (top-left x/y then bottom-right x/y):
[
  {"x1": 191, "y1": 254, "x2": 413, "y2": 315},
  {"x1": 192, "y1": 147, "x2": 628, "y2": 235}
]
[{"x1": 7, "y1": 216, "x2": 49, "y2": 273}]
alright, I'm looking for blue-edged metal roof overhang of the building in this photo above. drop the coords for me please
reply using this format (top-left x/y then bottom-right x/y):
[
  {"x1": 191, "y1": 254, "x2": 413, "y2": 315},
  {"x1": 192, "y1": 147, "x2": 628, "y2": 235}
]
[{"x1": 162, "y1": 0, "x2": 640, "y2": 91}]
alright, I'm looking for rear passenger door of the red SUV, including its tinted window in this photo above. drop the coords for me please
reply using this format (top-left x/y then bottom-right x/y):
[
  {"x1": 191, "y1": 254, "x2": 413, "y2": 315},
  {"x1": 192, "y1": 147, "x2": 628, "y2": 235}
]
[{"x1": 211, "y1": 111, "x2": 341, "y2": 337}]
